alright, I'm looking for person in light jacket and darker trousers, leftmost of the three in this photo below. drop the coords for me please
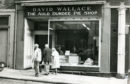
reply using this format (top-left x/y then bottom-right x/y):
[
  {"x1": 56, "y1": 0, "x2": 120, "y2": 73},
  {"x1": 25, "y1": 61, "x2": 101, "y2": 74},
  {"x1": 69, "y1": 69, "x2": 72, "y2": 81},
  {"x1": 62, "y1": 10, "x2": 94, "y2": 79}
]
[{"x1": 33, "y1": 44, "x2": 42, "y2": 77}]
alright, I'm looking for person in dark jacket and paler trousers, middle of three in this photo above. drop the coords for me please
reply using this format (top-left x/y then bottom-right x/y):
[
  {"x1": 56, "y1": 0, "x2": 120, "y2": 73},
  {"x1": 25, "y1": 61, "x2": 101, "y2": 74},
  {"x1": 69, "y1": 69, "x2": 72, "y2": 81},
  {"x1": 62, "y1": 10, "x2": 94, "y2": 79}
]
[{"x1": 43, "y1": 44, "x2": 52, "y2": 75}]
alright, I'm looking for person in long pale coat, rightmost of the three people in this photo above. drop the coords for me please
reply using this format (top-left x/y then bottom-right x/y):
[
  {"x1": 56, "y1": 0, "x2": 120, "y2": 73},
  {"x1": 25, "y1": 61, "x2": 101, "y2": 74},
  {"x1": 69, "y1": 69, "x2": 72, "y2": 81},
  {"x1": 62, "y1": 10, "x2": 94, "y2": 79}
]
[{"x1": 52, "y1": 48, "x2": 60, "y2": 74}]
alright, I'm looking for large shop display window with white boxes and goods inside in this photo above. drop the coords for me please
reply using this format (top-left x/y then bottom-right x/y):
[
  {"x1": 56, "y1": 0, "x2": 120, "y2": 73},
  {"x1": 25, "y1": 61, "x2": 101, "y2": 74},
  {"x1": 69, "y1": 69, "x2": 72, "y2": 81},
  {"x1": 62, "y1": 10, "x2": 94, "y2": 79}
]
[{"x1": 50, "y1": 20, "x2": 99, "y2": 66}]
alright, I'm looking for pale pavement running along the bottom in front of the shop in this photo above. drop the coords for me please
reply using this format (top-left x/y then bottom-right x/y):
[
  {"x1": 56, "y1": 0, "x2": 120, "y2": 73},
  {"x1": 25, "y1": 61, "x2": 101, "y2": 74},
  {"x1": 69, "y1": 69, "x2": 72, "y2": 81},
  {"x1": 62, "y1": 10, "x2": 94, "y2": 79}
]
[{"x1": 0, "y1": 68, "x2": 128, "y2": 84}]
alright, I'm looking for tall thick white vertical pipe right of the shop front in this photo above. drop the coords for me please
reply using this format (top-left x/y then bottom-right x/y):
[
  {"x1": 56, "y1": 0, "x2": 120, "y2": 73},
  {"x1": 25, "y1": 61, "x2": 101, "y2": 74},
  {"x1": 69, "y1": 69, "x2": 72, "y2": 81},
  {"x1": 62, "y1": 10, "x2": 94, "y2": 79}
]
[{"x1": 117, "y1": 3, "x2": 126, "y2": 78}]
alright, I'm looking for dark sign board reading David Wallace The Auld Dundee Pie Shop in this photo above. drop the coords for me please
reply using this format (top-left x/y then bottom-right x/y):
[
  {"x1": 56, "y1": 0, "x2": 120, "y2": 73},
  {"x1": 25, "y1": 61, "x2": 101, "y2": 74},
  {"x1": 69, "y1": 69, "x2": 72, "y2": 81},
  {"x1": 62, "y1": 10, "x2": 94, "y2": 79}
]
[{"x1": 24, "y1": 5, "x2": 102, "y2": 17}]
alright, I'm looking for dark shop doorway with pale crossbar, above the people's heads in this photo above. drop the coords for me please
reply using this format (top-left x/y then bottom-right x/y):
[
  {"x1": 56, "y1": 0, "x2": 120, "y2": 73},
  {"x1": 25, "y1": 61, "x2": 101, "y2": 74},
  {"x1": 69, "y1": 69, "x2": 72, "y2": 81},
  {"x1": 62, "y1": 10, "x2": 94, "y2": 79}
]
[{"x1": 34, "y1": 21, "x2": 52, "y2": 50}]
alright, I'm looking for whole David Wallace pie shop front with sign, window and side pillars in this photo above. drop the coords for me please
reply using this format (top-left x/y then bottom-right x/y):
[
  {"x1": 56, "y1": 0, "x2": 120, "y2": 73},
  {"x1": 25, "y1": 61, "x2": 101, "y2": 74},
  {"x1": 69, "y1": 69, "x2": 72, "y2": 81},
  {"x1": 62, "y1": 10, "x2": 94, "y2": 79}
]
[{"x1": 17, "y1": 2, "x2": 110, "y2": 73}]
